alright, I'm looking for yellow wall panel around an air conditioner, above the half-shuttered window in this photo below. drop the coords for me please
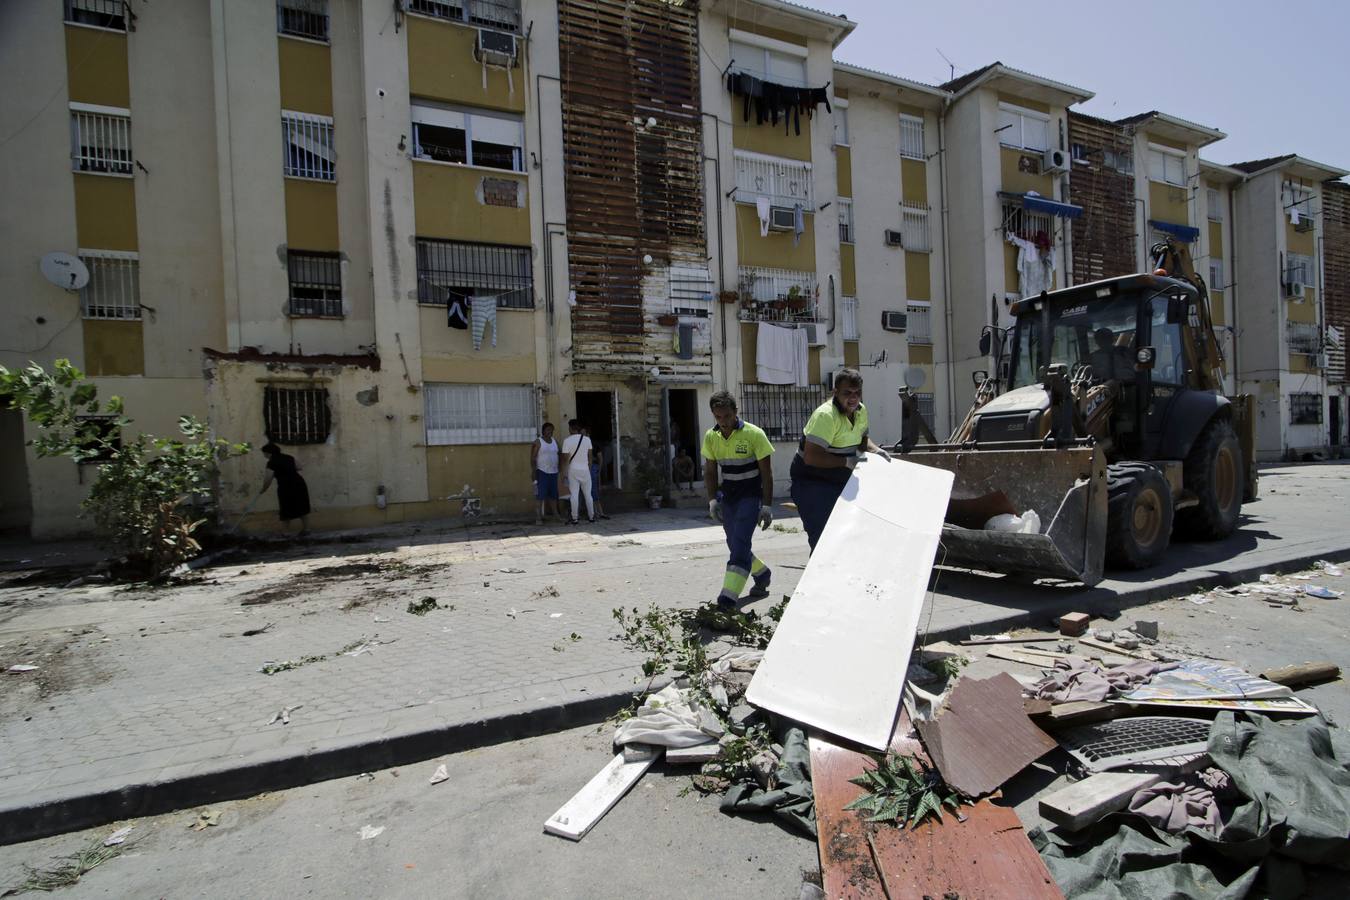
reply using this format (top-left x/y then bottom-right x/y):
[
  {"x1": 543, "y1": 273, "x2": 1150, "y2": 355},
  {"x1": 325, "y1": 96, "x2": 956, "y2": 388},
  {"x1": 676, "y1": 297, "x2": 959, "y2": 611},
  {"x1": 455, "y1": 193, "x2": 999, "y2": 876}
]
[{"x1": 406, "y1": 16, "x2": 525, "y2": 112}]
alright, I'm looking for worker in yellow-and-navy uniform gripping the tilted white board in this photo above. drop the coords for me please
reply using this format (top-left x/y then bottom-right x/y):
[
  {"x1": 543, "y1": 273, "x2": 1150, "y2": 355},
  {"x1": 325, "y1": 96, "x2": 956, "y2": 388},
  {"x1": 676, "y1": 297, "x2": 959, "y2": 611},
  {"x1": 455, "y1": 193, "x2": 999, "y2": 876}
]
[{"x1": 790, "y1": 368, "x2": 891, "y2": 552}]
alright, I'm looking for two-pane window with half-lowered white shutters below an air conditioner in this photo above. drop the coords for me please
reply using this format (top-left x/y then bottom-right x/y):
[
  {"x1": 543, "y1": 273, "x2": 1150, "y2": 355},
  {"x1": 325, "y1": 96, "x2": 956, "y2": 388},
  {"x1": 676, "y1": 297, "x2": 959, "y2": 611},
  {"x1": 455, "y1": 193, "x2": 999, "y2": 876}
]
[{"x1": 413, "y1": 100, "x2": 525, "y2": 171}]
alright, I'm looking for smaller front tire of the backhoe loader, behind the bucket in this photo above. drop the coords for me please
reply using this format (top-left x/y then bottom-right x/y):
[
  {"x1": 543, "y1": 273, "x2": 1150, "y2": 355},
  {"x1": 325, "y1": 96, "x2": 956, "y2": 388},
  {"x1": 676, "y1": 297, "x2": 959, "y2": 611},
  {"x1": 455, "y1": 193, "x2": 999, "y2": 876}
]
[{"x1": 1106, "y1": 463, "x2": 1172, "y2": 569}]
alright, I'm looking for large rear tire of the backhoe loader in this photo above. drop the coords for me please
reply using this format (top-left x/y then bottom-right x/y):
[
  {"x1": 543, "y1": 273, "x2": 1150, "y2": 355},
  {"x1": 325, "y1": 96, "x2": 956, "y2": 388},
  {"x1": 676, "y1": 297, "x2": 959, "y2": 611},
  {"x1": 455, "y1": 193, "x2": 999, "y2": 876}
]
[{"x1": 1177, "y1": 420, "x2": 1246, "y2": 541}]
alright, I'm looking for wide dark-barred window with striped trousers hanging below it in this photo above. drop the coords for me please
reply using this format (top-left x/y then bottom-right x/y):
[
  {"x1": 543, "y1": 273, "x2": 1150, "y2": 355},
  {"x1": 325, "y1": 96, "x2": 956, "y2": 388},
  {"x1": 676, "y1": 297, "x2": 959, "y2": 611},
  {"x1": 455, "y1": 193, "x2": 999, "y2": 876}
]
[{"x1": 417, "y1": 237, "x2": 535, "y2": 309}]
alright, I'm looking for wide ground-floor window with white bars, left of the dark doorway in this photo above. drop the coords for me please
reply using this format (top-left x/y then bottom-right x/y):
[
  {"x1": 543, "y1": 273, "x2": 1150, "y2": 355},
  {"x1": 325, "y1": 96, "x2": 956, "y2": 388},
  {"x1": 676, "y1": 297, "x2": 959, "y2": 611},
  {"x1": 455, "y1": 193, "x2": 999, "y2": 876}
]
[{"x1": 423, "y1": 385, "x2": 539, "y2": 447}]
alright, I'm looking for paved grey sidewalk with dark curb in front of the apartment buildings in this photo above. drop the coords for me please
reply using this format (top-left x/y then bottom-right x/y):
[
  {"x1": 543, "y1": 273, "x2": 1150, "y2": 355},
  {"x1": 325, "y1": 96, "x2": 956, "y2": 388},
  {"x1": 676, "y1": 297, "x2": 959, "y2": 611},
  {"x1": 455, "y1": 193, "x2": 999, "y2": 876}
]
[{"x1": 0, "y1": 466, "x2": 1350, "y2": 843}]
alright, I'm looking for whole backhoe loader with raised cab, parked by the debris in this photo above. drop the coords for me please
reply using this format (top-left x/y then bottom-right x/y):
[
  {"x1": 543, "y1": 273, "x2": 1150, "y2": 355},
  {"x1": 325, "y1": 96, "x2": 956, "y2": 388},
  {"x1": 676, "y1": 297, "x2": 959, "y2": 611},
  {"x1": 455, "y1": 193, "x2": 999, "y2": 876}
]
[{"x1": 895, "y1": 240, "x2": 1257, "y2": 586}]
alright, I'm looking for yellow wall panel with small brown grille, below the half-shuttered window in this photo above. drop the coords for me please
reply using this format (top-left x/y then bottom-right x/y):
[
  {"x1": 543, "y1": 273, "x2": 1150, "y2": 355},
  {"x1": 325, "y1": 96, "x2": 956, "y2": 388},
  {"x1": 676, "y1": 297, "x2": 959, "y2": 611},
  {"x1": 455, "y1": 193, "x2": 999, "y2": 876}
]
[{"x1": 413, "y1": 161, "x2": 529, "y2": 247}]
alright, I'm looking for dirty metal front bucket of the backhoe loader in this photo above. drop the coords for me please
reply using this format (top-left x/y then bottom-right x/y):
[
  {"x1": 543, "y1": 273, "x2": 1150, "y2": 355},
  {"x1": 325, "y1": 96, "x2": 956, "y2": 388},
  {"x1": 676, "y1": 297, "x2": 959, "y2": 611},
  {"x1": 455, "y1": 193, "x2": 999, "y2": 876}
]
[{"x1": 905, "y1": 441, "x2": 1107, "y2": 587}]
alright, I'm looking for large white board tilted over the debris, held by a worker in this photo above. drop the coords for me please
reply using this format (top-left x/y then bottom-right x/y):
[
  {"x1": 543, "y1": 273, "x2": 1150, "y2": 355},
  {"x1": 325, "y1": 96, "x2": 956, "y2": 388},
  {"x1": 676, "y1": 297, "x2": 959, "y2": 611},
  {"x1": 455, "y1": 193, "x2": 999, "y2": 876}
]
[{"x1": 747, "y1": 459, "x2": 953, "y2": 749}]
